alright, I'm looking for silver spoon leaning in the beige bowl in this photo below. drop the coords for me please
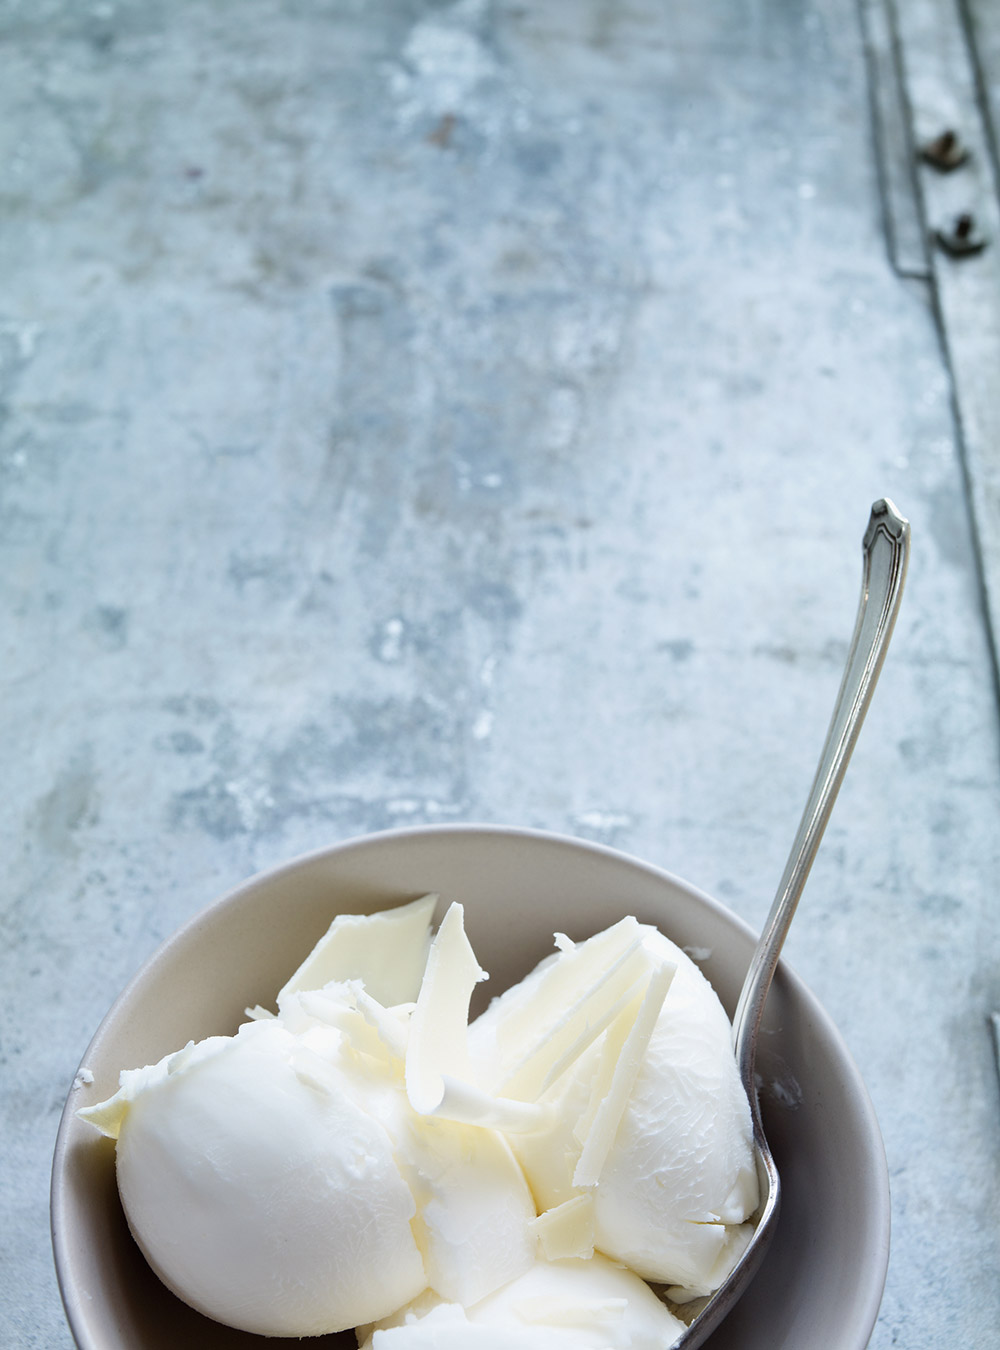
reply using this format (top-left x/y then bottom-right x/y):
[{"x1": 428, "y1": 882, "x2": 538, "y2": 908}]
[{"x1": 672, "y1": 498, "x2": 910, "y2": 1350}]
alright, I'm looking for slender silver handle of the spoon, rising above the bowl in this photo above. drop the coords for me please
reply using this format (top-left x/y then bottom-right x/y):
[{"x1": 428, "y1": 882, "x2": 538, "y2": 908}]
[{"x1": 733, "y1": 497, "x2": 910, "y2": 1096}]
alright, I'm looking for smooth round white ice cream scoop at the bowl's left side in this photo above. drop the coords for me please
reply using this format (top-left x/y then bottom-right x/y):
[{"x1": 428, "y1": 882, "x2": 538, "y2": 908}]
[{"x1": 75, "y1": 1019, "x2": 426, "y2": 1337}]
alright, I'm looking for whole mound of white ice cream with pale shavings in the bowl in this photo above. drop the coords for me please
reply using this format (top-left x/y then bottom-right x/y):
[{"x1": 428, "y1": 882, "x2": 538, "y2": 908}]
[{"x1": 80, "y1": 896, "x2": 757, "y2": 1350}]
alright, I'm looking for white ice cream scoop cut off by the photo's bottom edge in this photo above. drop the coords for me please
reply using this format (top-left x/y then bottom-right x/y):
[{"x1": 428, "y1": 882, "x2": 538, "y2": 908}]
[{"x1": 358, "y1": 1256, "x2": 684, "y2": 1350}]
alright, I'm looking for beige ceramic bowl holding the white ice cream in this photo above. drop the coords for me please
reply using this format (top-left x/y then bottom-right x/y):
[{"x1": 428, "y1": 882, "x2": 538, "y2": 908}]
[{"x1": 51, "y1": 826, "x2": 889, "y2": 1350}]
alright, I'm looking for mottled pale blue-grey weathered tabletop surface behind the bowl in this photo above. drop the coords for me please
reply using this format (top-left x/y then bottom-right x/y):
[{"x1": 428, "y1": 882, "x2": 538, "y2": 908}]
[{"x1": 0, "y1": 0, "x2": 1000, "y2": 1350}]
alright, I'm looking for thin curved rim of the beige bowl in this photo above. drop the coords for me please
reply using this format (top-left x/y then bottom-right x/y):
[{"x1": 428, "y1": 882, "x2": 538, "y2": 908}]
[{"x1": 49, "y1": 822, "x2": 891, "y2": 1350}]
